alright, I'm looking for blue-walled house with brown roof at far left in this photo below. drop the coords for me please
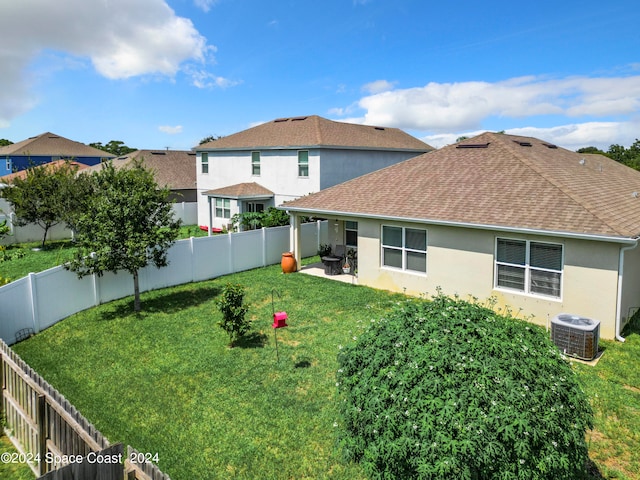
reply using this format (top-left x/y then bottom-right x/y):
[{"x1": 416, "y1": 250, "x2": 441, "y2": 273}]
[{"x1": 0, "y1": 132, "x2": 115, "y2": 176}]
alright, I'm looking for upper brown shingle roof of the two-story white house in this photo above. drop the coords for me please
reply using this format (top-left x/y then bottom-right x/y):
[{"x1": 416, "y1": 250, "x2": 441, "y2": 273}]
[{"x1": 196, "y1": 115, "x2": 433, "y2": 153}]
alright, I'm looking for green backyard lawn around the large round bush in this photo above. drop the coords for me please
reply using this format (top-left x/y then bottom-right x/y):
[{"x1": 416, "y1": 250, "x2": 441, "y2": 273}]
[{"x1": 5, "y1": 253, "x2": 640, "y2": 480}]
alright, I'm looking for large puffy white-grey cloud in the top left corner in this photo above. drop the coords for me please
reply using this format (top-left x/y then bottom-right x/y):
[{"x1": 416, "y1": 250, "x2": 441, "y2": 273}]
[{"x1": 0, "y1": 0, "x2": 213, "y2": 123}]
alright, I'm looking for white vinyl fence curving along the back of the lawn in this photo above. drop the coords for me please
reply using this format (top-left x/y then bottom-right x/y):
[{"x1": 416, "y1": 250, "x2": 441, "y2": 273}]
[{"x1": 0, "y1": 221, "x2": 327, "y2": 345}]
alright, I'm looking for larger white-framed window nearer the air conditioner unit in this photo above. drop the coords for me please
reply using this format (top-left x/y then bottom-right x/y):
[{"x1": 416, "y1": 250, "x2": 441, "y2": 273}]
[{"x1": 495, "y1": 238, "x2": 564, "y2": 298}]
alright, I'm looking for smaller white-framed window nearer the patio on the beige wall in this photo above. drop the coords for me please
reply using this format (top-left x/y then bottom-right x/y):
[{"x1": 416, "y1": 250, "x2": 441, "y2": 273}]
[{"x1": 381, "y1": 225, "x2": 427, "y2": 273}]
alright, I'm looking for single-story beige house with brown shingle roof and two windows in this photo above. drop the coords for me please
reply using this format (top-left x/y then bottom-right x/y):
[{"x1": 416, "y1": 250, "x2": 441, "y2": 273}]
[{"x1": 281, "y1": 133, "x2": 640, "y2": 339}]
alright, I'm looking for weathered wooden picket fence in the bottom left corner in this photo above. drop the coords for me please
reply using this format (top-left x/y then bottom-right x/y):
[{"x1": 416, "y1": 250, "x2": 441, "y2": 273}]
[{"x1": 0, "y1": 340, "x2": 170, "y2": 480}]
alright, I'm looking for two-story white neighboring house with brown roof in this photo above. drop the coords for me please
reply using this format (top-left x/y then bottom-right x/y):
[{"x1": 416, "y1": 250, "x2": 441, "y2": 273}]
[{"x1": 194, "y1": 115, "x2": 433, "y2": 228}]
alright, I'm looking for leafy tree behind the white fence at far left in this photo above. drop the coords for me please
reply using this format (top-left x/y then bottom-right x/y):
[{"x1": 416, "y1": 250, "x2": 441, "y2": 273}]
[{"x1": 0, "y1": 162, "x2": 78, "y2": 248}]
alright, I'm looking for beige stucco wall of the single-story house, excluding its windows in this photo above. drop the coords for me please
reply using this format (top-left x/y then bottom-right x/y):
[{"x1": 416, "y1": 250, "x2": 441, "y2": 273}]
[{"x1": 350, "y1": 219, "x2": 624, "y2": 339}]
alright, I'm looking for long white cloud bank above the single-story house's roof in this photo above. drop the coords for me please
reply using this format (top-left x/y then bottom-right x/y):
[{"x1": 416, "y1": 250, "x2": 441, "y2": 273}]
[{"x1": 358, "y1": 76, "x2": 640, "y2": 133}]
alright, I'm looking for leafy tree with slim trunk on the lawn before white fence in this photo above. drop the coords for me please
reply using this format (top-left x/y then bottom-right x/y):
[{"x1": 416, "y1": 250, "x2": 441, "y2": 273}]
[{"x1": 65, "y1": 161, "x2": 180, "y2": 313}]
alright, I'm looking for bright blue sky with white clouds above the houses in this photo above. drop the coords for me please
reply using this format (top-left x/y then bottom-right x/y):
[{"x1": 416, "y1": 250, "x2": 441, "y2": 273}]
[{"x1": 0, "y1": 0, "x2": 640, "y2": 150}]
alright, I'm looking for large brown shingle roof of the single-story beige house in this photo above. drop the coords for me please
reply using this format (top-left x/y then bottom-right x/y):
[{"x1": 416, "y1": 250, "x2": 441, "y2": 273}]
[{"x1": 283, "y1": 133, "x2": 640, "y2": 237}]
